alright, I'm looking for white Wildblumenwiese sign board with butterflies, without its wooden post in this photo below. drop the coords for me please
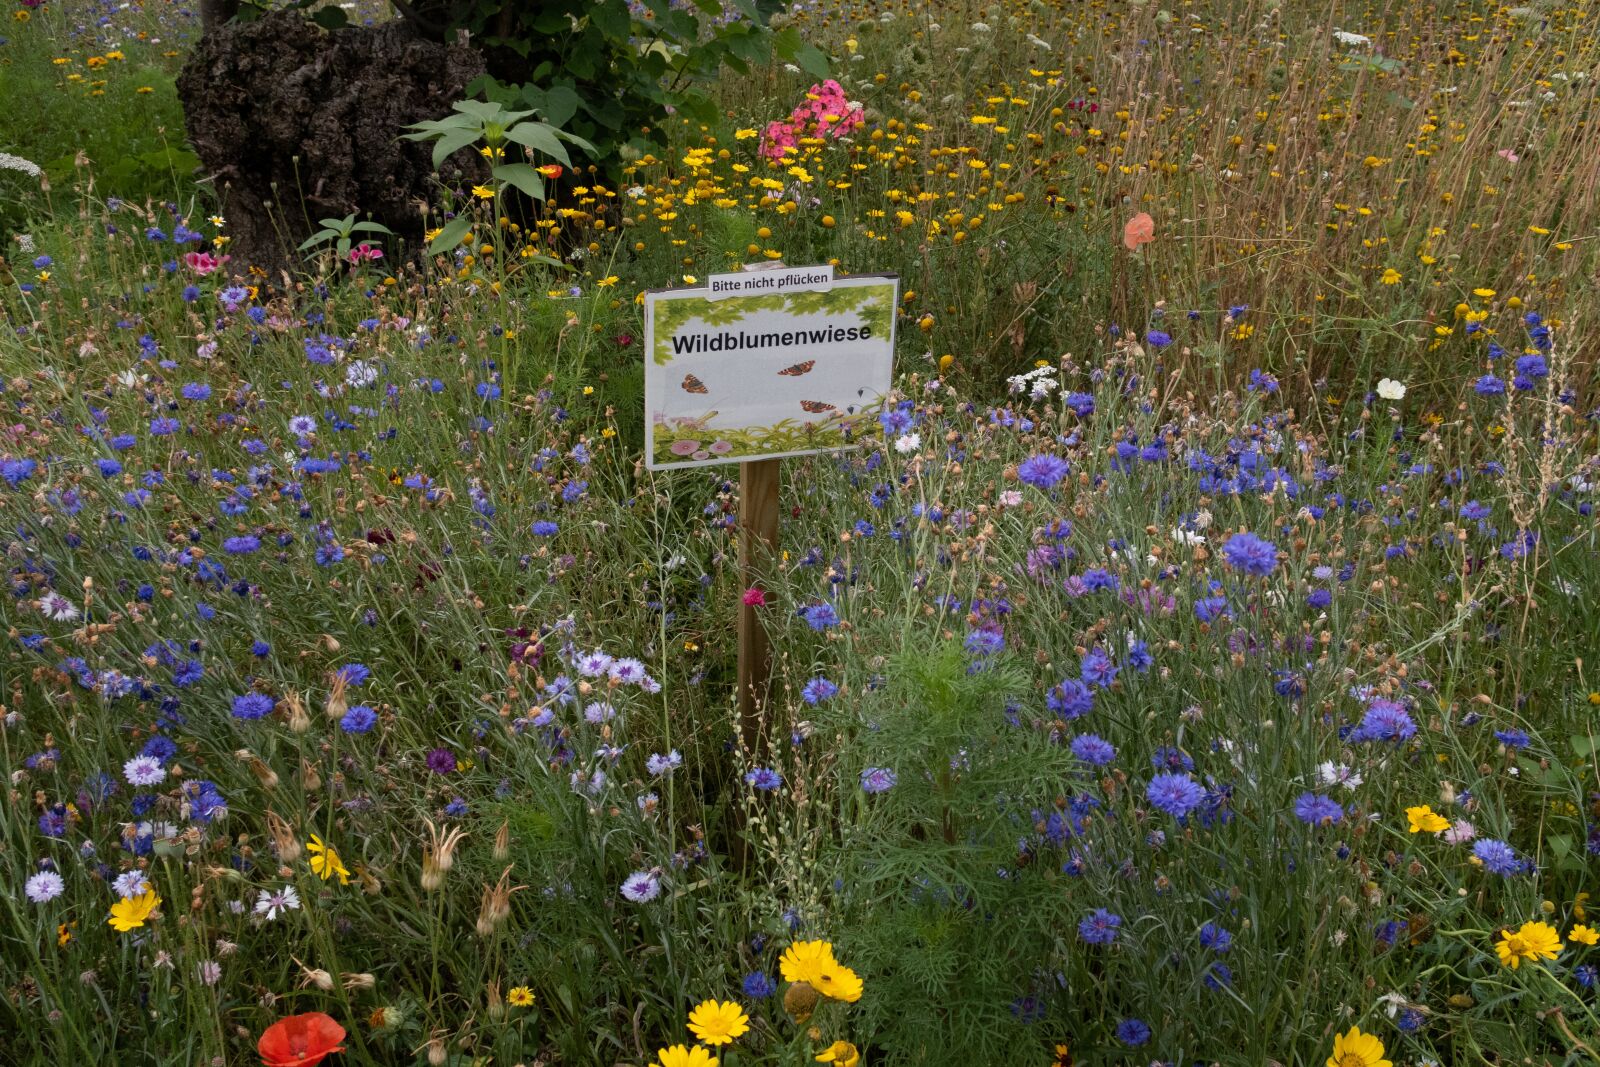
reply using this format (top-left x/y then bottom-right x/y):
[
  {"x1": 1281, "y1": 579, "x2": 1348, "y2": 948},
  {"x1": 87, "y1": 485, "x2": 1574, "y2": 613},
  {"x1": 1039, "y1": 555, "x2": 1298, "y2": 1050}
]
[{"x1": 645, "y1": 267, "x2": 899, "y2": 470}]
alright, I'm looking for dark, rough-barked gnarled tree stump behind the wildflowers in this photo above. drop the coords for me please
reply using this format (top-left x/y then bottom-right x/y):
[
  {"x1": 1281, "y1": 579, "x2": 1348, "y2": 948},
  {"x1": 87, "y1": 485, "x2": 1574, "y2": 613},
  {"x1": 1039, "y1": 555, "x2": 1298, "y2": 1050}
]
[{"x1": 178, "y1": 11, "x2": 483, "y2": 272}]
